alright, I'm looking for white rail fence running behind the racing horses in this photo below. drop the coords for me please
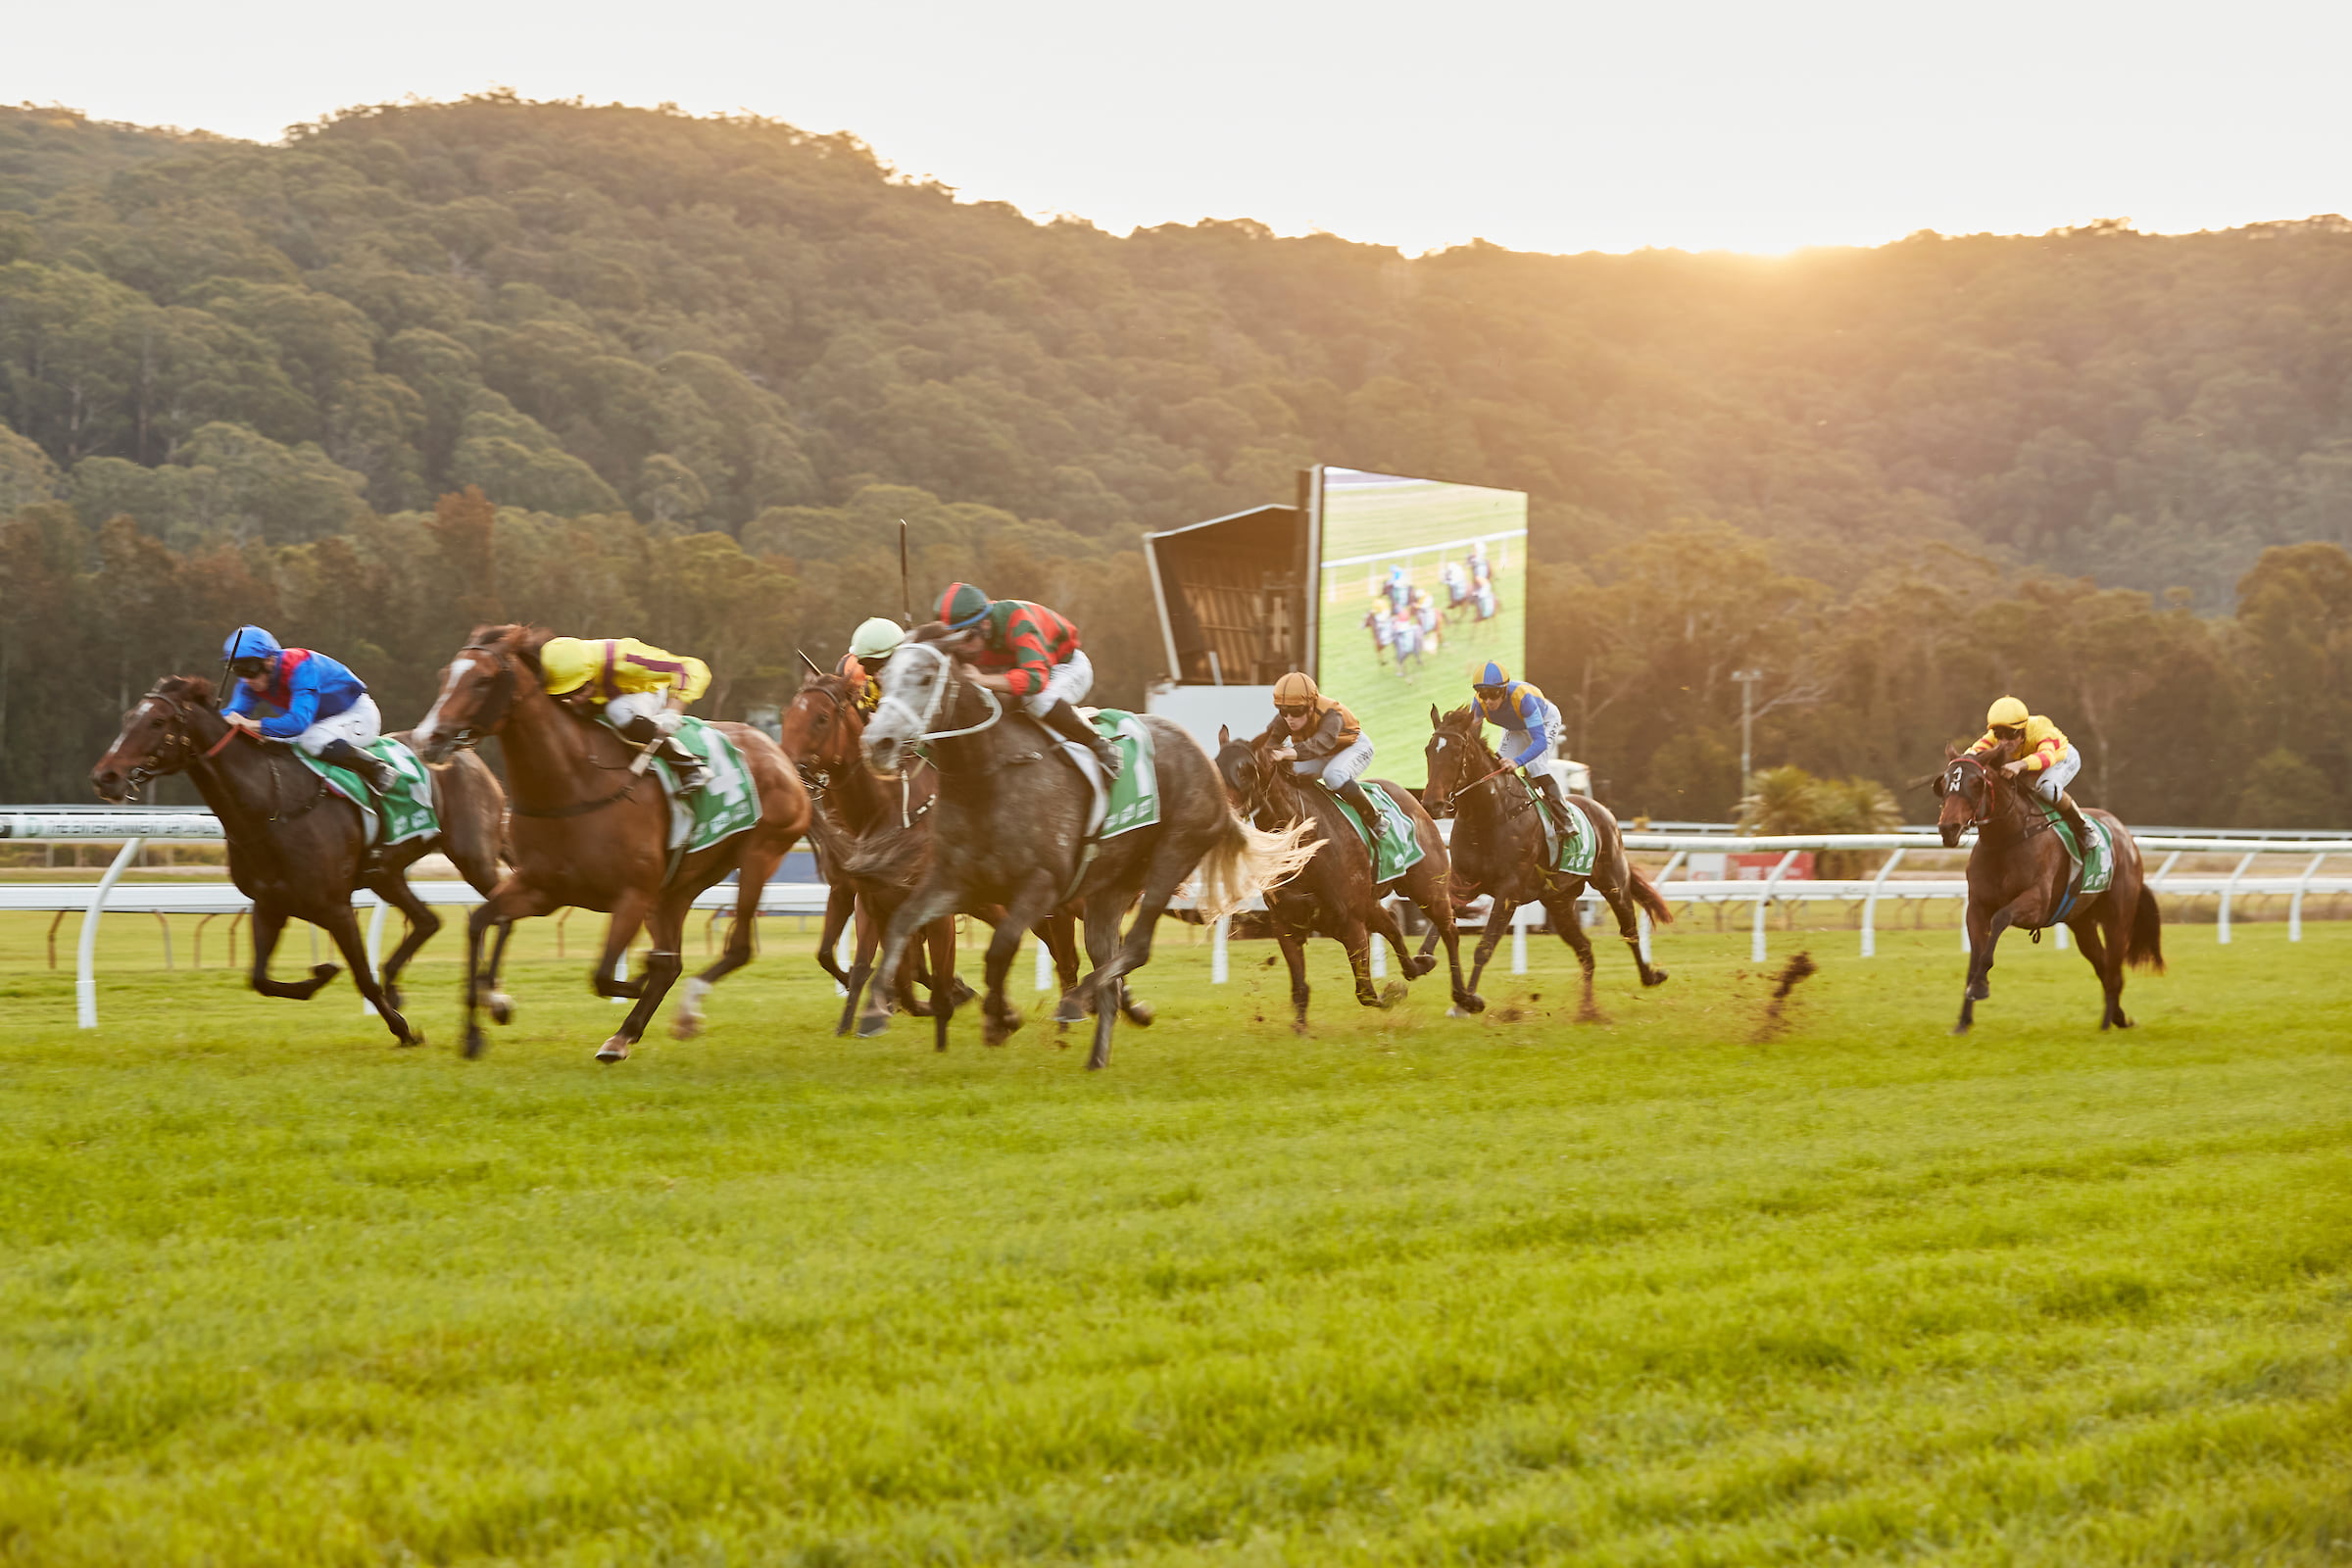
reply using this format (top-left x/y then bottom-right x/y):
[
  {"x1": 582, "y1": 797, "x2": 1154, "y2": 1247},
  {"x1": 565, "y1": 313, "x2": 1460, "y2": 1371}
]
[{"x1": 0, "y1": 807, "x2": 2352, "y2": 1030}]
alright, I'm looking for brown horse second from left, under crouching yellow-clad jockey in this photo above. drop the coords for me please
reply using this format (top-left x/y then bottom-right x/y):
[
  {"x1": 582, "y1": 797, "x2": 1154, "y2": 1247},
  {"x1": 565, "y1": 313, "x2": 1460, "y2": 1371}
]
[{"x1": 416, "y1": 625, "x2": 809, "y2": 1062}]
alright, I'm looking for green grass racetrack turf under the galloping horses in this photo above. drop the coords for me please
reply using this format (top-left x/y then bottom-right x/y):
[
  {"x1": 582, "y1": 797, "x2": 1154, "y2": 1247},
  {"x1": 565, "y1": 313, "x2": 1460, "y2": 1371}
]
[{"x1": 0, "y1": 917, "x2": 2352, "y2": 1568}]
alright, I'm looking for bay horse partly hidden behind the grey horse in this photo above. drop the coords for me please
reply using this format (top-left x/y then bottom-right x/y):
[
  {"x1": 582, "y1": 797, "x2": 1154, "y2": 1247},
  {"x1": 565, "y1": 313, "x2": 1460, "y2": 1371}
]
[{"x1": 778, "y1": 672, "x2": 1084, "y2": 1051}]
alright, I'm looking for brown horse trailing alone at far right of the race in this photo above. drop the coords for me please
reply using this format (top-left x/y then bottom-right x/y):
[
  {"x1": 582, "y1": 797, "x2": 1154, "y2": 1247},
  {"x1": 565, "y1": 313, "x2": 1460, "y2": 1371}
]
[{"x1": 1936, "y1": 745, "x2": 2164, "y2": 1034}]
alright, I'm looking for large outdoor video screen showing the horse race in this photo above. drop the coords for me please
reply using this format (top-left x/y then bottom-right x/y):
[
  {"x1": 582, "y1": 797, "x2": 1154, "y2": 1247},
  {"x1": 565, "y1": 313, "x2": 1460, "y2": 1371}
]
[{"x1": 1315, "y1": 467, "x2": 1527, "y2": 761}]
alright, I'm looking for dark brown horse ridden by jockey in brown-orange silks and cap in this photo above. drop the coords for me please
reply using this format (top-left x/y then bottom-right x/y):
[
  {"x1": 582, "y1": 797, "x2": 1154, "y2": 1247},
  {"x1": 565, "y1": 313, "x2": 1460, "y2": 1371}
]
[{"x1": 1216, "y1": 726, "x2": 1487, "y2": 1034}]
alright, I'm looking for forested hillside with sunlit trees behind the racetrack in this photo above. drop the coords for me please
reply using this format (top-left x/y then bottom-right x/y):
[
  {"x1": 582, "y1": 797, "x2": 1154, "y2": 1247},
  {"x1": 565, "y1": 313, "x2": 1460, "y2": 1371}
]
[{"x1": 0, "y1": 99, "x2": 2352, "y2": 825}]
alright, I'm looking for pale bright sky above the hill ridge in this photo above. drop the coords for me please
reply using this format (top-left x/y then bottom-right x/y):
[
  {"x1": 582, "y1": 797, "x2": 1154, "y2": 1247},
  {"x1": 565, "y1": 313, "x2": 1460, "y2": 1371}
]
[{"x1": 0, "y1": 0, "x2": 2352, "y2": 252}]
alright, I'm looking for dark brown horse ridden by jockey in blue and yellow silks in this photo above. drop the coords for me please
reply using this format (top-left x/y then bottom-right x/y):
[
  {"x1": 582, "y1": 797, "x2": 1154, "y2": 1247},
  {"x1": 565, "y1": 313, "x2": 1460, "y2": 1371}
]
[{"x1": 1423, "y1": 706, "x2": 1675, "y2": 1022}]
